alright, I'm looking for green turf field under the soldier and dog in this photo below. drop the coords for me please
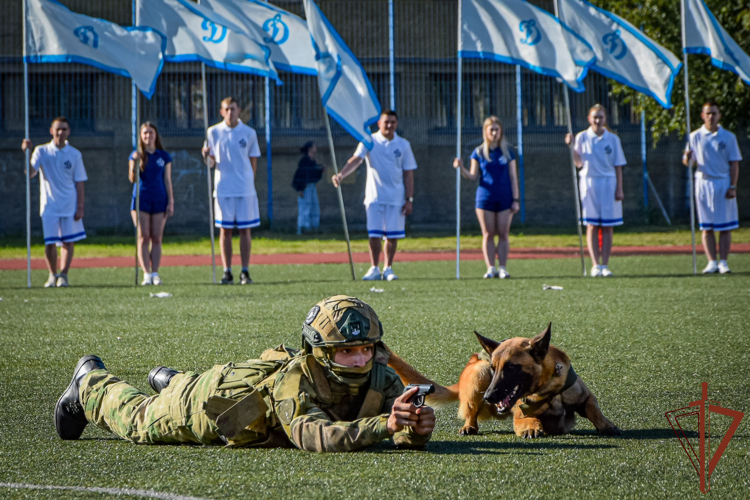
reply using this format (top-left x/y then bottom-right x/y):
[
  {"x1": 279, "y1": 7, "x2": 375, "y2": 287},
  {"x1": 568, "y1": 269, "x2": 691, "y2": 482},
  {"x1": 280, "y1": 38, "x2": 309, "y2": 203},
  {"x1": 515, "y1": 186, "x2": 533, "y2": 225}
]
[{"x1": 0, "y1": 255, "x2": 750, "y2": 499}]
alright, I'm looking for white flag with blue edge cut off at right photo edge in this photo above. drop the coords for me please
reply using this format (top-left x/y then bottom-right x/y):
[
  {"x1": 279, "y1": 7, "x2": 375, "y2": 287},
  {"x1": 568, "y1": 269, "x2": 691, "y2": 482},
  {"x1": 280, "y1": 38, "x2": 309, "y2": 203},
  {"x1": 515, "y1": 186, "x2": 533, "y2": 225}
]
[{"x1": 683, "y1": 0, "x2": 750, "y2": 85}]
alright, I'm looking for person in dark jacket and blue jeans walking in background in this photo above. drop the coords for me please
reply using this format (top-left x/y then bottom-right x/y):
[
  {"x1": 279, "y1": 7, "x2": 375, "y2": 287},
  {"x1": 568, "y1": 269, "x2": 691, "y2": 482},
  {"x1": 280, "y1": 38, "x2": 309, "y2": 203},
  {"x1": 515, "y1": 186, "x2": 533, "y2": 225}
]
[{"x1": 292, "y1": 141, "x2": 325, "y2": 234}]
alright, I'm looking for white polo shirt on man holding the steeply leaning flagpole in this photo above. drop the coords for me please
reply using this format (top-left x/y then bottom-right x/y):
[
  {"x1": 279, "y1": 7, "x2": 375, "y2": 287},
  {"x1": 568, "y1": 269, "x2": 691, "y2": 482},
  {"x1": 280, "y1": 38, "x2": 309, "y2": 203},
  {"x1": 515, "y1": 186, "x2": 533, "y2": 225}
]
[{"x1": 354, "y1": 131, "x2": 417, "y2": 207}]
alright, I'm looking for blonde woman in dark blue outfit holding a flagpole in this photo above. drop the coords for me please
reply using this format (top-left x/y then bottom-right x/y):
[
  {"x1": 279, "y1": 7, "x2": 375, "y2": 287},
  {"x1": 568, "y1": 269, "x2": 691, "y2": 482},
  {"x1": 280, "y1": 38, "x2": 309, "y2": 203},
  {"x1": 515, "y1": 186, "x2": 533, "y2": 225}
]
[{"x1": 453, "y1": 116, "x2": 519, "y2": 278}]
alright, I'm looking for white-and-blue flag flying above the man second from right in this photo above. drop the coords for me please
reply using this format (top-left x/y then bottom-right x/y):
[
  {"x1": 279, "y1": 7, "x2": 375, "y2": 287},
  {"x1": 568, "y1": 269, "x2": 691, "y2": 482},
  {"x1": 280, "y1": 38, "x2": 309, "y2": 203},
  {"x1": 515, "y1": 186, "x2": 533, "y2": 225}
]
[{"x1": 559, "y1": 0, "x2": 682, "y2": 108}]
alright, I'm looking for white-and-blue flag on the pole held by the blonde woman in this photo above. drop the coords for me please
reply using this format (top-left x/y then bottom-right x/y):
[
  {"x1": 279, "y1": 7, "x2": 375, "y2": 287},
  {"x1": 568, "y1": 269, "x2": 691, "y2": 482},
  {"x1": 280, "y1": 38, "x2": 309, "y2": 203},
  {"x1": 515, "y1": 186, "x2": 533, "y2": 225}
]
[{"x1": 458, "y1": 0, "x2": 596, "y2": 92}]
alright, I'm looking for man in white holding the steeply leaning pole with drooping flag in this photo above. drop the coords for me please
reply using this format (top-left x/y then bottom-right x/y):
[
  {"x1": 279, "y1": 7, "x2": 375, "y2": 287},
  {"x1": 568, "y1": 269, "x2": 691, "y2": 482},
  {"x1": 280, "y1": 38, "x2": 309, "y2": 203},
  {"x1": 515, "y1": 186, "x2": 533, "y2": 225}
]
[{"x1": 333, "y1": 111, "x2": 417, "y2": 281}]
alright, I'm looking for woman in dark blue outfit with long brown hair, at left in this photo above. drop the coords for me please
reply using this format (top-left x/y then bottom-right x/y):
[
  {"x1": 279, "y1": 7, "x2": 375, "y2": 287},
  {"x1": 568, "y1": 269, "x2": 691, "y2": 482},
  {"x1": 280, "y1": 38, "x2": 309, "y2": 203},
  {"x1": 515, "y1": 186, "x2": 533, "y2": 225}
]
[{"x1": 128, "y1": 122, "x2": 174, "y2": 285}]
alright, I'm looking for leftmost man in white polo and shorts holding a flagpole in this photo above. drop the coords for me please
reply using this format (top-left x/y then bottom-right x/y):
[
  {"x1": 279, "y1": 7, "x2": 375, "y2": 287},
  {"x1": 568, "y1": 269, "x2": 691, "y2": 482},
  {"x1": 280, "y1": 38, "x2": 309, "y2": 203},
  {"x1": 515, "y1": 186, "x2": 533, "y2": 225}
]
[{"x1": 21, "y1": 116, "x2": 88, "y2": 288}]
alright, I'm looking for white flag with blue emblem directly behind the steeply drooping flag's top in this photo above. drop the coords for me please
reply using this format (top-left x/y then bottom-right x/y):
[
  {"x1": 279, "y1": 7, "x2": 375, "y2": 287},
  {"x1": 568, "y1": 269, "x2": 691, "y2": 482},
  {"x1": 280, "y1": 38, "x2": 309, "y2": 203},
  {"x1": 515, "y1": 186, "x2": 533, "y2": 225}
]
[{"x1": 201, "y1": 0, "x2": 318, "y2": 75}]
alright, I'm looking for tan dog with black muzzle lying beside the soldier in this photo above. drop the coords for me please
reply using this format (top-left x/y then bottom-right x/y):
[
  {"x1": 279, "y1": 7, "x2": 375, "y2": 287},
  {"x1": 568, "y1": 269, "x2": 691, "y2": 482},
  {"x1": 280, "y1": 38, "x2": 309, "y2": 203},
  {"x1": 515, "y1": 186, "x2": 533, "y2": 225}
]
[{"x1": 388, "y1": 323, "x2": 621, "y2": 438}]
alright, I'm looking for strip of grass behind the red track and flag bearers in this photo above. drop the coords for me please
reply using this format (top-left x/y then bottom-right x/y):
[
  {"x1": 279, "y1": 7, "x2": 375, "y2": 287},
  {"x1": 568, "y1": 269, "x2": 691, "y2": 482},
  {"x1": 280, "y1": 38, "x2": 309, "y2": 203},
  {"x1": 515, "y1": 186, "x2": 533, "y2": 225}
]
[{"x1": 0, "y1": 227, "x2": 750, "y2": 259}]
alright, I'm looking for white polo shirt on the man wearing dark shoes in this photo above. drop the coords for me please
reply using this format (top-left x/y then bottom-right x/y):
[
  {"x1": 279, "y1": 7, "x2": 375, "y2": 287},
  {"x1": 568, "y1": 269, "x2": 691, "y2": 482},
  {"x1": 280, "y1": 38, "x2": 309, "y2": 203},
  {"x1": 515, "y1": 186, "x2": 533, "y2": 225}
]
[{"x1": 207, "y1": 121, "x2": 260, "y2": 197}]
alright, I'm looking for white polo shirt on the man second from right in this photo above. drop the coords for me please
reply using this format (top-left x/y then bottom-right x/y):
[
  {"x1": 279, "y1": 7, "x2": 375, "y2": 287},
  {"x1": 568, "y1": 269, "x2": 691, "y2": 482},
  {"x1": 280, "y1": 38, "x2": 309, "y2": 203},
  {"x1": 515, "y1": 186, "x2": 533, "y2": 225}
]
[{"x1": 574, "y1": 127, "x2": 627, "y2": 177}]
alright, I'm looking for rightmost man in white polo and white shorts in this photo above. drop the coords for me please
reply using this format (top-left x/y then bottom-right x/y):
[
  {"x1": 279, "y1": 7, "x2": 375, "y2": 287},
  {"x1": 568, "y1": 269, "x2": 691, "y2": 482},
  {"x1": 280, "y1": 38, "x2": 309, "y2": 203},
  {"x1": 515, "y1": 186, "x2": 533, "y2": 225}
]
[{"x1": 682, "y1": 101, "x2": 742, "y2": 274}]
